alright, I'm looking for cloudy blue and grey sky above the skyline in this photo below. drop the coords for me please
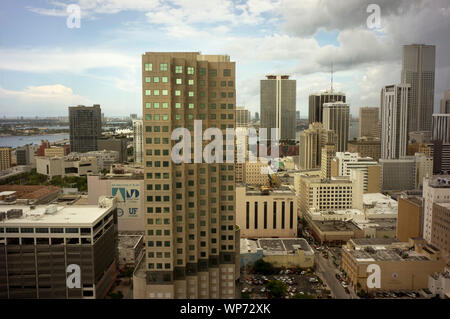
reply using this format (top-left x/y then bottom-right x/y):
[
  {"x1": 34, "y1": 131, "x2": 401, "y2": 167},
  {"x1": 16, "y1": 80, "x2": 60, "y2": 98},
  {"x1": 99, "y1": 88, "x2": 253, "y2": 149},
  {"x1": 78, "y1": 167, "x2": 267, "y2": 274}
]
[{"x1": 0, "y1": 0, "x2": 450, "y2": 118}]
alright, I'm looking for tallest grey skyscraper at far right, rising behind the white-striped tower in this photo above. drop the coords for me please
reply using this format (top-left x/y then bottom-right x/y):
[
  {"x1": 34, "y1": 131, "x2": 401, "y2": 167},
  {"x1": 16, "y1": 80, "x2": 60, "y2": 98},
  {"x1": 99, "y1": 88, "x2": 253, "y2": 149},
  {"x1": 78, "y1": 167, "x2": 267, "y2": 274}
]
[{"x1": 401, "y1": 44, "x2": 436, "y2": 132}]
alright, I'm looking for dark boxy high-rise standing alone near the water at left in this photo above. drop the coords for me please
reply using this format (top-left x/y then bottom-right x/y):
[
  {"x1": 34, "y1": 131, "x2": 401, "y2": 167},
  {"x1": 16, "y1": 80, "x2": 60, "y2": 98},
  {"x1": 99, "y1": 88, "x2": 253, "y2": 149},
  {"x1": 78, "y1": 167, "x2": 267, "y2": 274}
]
[{"x1": 69, "y1": 104, "x2": 102, "y2": 153}]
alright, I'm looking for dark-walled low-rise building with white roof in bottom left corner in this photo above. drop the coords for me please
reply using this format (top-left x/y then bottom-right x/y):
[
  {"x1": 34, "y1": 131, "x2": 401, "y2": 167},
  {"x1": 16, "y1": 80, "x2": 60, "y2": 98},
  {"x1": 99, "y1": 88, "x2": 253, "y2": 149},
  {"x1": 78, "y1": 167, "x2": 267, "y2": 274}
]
[{"x1": 0, "y1": 198, "x2": 117, "y2": 299}]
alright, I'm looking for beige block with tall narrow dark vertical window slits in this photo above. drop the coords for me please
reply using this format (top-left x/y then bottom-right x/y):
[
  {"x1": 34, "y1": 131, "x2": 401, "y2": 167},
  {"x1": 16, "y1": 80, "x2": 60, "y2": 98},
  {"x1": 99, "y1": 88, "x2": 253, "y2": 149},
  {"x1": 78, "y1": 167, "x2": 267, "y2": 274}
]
[{"x1": 236, "y1": 185, "x2": 297, "y2": 238}]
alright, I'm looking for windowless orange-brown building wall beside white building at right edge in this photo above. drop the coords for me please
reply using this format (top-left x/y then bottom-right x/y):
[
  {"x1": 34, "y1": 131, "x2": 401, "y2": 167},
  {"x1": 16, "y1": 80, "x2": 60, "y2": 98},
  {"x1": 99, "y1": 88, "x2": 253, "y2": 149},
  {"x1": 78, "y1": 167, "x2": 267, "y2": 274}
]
[{"x1": 397, "y1": 196, "x2": 423, "y2": 242}]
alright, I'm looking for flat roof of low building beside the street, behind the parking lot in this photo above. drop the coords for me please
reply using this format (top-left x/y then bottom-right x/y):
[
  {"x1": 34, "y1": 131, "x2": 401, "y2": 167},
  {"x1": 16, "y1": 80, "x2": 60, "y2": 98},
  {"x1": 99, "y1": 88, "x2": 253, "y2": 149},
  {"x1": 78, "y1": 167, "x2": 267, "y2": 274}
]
[{"x1": 258, "y1": 238, "x2": 314, "y2": 255}]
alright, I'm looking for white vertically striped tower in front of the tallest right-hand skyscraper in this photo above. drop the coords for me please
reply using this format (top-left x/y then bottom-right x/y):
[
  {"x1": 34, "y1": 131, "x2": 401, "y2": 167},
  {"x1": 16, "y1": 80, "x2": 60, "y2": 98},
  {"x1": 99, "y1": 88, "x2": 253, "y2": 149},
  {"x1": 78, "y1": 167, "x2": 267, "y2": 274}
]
[{"x1": 381, "y1": 84, "x2": 411, "y2": 159}]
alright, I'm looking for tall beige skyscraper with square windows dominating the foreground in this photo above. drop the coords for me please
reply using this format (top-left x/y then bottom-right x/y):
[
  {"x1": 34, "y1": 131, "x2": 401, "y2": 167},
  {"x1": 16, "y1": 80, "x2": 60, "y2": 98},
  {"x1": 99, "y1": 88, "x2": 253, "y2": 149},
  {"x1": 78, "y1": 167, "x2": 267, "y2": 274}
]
[{"x1": 142, "y1": 52, "x2": 239, "y2": 299}]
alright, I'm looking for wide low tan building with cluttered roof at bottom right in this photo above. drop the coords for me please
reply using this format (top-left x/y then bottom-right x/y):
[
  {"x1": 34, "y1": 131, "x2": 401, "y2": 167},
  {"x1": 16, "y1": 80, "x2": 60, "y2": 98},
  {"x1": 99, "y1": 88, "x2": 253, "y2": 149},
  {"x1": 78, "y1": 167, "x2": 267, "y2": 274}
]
[{"x1": 341, "y1": 238, "x2": 445, "y2": 291}]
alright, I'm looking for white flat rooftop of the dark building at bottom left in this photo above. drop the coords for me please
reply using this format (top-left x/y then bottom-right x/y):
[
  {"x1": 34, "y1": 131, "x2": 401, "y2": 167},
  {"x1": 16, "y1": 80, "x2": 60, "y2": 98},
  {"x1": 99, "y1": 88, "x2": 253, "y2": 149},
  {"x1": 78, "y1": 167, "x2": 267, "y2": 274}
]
[{"x1": 0, "y1": 205, "x2": 111, "y2": 227}]
